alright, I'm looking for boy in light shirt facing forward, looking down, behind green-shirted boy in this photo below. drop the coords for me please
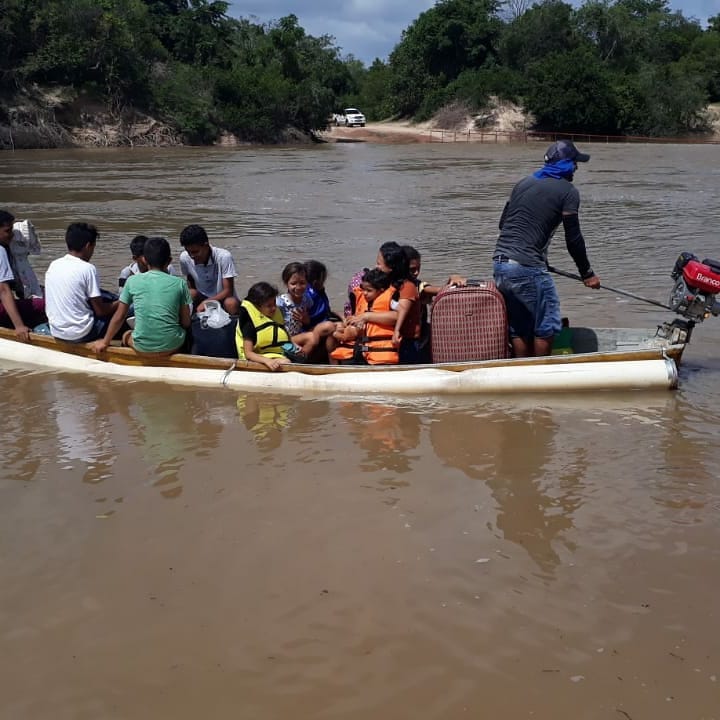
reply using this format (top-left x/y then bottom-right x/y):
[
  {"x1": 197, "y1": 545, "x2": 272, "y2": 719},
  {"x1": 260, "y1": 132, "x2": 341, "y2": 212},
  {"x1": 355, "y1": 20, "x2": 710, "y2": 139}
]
[{"x1": 180, "y1": 225, "x2": 240, "y2": 315}]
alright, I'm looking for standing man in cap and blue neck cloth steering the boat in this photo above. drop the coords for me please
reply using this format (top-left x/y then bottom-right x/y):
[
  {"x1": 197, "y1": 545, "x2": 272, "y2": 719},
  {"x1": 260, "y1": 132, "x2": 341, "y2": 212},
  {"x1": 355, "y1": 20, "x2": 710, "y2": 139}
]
[{"x1": 493, "y1": 140, "x2": 600, "y2": 357}]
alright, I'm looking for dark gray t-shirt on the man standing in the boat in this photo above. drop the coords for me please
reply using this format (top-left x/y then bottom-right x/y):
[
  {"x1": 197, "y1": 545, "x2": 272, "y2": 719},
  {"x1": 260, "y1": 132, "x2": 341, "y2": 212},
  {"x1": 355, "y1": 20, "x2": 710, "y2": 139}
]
[{"x1": 493, "y1": 175, "x2": 580, "y2": 267}]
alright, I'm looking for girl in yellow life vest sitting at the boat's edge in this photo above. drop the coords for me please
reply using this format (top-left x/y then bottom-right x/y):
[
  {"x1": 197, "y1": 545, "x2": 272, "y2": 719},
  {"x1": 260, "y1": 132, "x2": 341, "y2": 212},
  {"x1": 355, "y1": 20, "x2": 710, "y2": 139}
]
[{"x1": 235, "y1": 282, "x2": 302, "y2": 370}]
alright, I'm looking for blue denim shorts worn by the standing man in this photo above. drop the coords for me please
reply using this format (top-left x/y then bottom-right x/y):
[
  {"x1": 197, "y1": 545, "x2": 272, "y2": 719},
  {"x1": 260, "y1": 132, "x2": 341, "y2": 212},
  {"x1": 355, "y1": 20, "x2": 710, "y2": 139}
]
[{"x1": 493, "y1": 261, "x2": 562, "y2": 338}]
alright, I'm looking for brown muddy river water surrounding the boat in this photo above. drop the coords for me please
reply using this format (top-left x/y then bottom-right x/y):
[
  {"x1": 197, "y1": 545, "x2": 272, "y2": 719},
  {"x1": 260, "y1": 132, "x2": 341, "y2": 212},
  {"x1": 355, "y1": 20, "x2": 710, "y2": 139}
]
[{"x1": 0, "y1": 144, "x2": 720, "y2": 720}]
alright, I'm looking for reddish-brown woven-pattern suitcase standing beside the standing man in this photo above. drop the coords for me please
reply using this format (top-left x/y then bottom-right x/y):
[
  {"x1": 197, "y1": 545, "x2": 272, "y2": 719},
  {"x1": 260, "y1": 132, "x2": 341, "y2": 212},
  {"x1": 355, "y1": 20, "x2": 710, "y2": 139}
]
[{"x1": 430, "y1": 280, "x2": 510, "y2": 362}]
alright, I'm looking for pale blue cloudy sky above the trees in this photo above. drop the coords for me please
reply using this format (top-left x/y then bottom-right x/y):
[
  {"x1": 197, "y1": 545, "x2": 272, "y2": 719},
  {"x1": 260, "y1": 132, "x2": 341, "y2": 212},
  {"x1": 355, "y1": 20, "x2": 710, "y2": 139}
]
[{"x1": 228, "y1": 0, "x2": 720, "y2": 65}]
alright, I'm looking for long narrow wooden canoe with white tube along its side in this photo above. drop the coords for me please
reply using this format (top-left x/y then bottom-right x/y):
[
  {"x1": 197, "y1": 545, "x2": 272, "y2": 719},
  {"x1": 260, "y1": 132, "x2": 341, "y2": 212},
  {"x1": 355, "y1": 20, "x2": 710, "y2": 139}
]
[{"x1": 0, "y1": 328, "x2": 685, "y2": 395}]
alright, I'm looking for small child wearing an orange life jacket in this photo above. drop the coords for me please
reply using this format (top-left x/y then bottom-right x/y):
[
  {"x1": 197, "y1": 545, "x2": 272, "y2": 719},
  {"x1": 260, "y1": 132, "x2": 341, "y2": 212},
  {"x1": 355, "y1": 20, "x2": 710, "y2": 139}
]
[{"x1": 328, "y1": 268, "x2": 398, "y2": 365}]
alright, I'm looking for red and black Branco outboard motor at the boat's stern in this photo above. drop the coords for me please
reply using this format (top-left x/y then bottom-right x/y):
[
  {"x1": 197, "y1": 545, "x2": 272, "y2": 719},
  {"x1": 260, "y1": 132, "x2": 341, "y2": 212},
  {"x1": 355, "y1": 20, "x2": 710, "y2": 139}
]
[{"x1": 669, "y1": 252, "x2": 720, "y2": 322}]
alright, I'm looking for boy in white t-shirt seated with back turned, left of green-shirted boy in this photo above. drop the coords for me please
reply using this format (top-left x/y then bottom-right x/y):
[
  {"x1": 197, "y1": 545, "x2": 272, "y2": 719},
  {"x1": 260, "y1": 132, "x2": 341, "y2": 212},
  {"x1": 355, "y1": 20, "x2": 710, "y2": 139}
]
[{"x1": 45, "y1": 223, "x2": 117, "y2": 343}]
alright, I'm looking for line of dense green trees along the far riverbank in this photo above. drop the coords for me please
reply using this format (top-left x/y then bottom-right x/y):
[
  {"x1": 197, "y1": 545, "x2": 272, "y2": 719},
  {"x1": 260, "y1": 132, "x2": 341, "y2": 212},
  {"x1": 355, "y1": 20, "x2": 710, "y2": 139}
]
[{"x1": 0, "y1": 0, "x2": 720, "y2": 143}]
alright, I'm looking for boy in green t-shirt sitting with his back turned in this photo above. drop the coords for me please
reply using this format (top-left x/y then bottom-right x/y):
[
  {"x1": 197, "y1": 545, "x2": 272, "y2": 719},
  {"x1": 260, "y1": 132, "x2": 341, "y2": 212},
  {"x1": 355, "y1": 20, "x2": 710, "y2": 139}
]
[{"x1": 93, "y1": 237, "x2": 192, "y2": 355}]
